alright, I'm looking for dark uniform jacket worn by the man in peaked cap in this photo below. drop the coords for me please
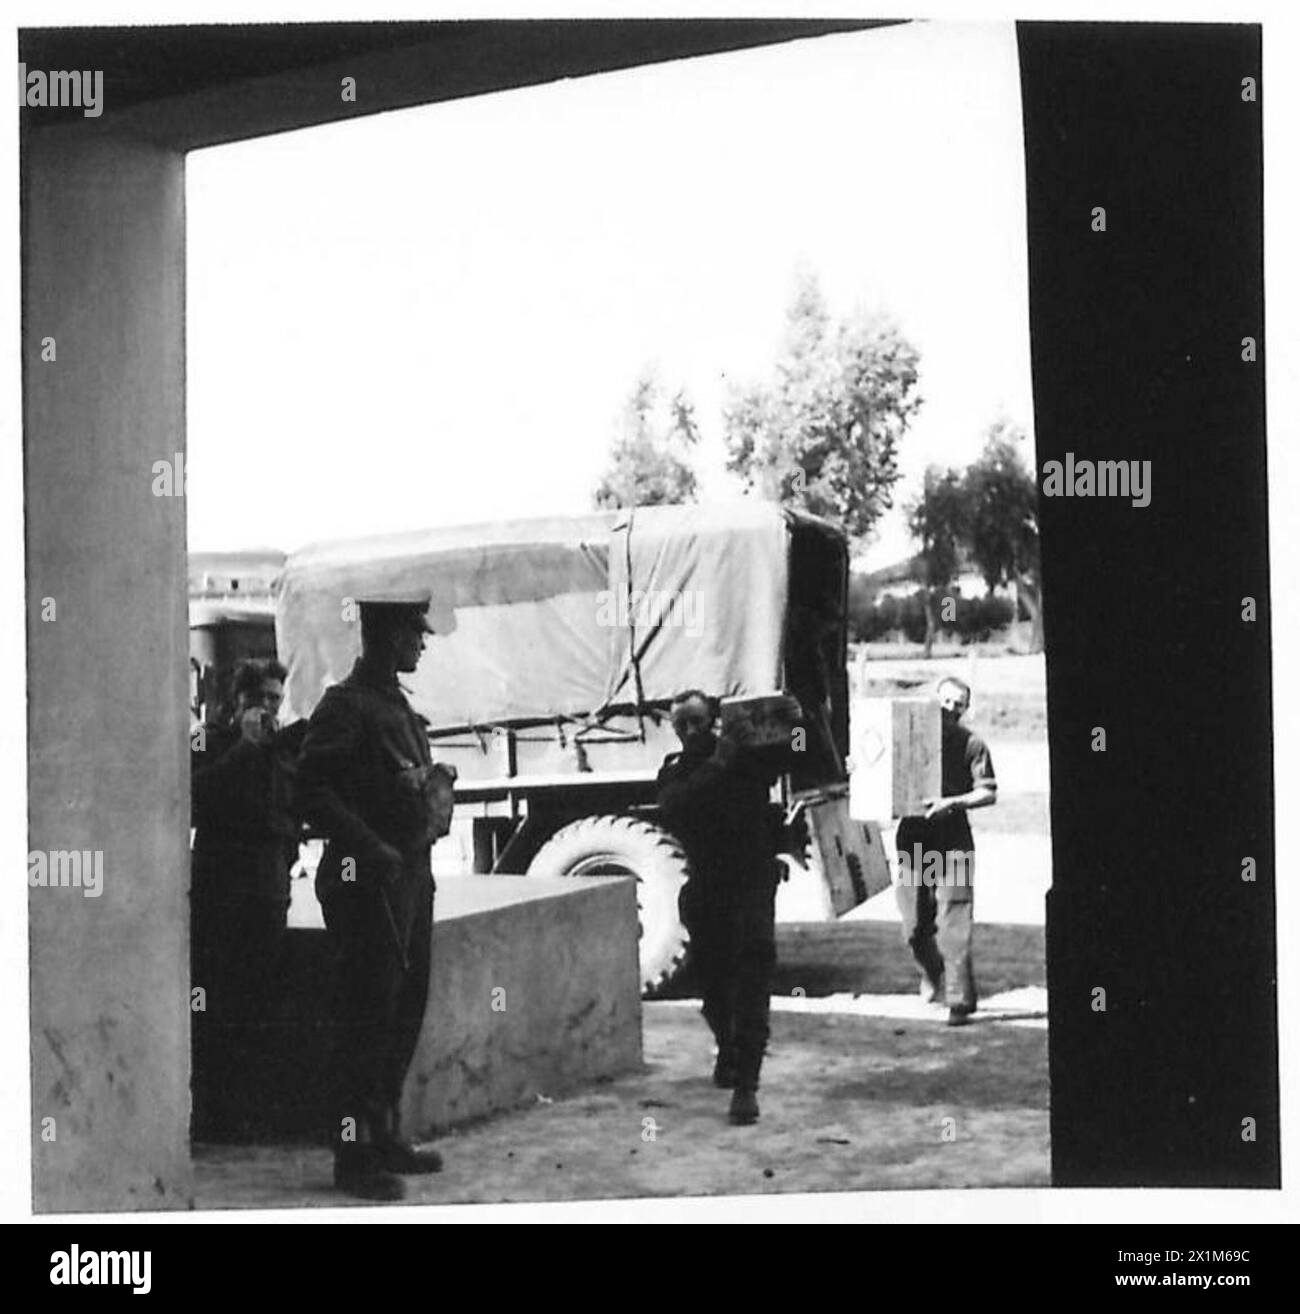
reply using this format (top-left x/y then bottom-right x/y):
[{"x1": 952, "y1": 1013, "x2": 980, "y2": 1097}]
[{"x1": 298, "y1": 658, "x2": 435, "y2": 897}]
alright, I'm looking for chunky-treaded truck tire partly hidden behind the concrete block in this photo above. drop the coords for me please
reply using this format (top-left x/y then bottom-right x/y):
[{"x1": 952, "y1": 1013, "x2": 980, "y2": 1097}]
[{"x1": 528, "y1": 816, "x2": 690, "y2": 995}]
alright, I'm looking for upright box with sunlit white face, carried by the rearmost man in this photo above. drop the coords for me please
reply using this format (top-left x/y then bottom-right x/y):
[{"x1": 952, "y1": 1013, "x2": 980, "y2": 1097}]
[{"x1": 849, "y1": 698, "x2": 942, "y2": 821}]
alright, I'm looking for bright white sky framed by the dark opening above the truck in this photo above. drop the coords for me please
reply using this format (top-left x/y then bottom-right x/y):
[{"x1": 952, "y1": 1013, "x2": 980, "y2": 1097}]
[{"x1": 187, "y1": 22, "x2": 1033, "y2": 565}]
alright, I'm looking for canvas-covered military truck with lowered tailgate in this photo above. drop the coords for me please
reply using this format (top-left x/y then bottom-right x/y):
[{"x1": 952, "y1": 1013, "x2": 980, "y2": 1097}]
[{"x1": 273, "y1": 501, "x2": 889, "y2": 993}]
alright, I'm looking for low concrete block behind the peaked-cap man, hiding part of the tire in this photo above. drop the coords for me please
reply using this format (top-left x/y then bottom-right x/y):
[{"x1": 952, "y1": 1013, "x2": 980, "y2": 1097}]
[{"x1": 402, "y1": 876, "x2": 641, "y2": 1134}]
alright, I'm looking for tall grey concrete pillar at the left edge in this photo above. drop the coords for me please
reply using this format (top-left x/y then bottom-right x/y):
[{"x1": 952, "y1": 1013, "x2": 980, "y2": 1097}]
[{"x1": 22, "y1": 125, "x2": 189, "y2": 1210}]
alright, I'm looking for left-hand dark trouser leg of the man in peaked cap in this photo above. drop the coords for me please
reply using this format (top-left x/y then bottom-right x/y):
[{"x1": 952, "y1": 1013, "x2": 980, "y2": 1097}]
[{"x1": 323, "y1": 884, "x2": 406, "y2": 1148}]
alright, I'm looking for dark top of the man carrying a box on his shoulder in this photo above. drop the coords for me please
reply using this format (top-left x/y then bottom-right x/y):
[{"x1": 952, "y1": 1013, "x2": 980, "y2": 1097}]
[{"x1": 657, "y1": 750, "x2": 781, "y2": 884}]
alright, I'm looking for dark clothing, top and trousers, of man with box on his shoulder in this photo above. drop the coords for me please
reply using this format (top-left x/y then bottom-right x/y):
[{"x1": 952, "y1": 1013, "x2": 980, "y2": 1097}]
[{"x1": 659, "y1": 742, "x2": 781, "y2": 1089}]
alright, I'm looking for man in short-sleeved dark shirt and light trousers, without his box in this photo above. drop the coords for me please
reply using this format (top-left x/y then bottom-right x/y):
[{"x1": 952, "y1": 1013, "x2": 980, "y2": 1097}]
[{"x1": 895, "y1": 675, "x2": 998, "y2": 1026}]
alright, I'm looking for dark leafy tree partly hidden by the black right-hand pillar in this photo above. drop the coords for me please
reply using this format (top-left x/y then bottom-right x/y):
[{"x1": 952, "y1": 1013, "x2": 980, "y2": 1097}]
[{"x1": 965, "y1": 419, "x2": 1042, "y2": 652}]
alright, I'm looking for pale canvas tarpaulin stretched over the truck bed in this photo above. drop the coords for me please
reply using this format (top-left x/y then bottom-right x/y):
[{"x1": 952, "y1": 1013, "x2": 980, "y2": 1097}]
[{"x1": 276, "y1": 501, "x2": 790, "y2": 731}]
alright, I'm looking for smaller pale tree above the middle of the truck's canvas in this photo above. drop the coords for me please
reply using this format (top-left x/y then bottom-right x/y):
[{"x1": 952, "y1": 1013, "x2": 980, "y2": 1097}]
[{"x1": 594, "y1": 371, "x2": 699, "y2": 510}]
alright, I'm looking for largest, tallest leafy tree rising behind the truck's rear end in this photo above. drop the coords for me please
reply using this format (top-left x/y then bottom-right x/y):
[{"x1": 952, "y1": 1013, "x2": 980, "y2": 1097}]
[{"x1": 723, "y1": 279, "x2": 921, "y2": 537}]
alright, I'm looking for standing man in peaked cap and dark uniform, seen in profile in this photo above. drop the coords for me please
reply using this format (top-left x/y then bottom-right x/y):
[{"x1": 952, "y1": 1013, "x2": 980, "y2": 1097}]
[{"x1": 298, "y1": 593, "x2": 455, "y2": 1200}]
